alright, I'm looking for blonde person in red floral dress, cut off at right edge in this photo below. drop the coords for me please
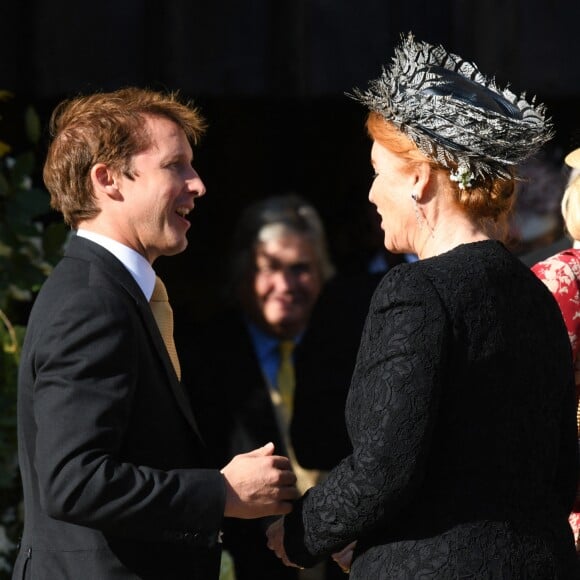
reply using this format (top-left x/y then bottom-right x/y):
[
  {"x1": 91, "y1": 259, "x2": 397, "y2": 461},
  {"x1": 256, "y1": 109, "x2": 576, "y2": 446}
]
[{"x1": 532, "y1": 149, "x2": 580, "y2": 552}]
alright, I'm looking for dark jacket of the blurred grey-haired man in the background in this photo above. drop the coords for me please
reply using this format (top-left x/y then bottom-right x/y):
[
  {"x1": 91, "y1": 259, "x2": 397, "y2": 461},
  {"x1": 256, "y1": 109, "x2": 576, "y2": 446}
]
[{"x1": 176, "y1": 276, "x2": 379, "y2": 580}]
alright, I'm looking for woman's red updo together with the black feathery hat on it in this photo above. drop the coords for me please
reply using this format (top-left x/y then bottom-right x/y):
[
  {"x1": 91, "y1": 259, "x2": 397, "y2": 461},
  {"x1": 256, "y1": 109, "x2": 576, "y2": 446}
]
[{"x1": 350, "y1": 34, "x2": 553, "y2": 238}]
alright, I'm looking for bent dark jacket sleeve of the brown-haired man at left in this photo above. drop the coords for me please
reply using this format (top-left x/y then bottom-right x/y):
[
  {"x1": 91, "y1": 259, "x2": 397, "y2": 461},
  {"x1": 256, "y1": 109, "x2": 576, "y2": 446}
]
[{"x1": 34, "y1": 288, "x2": 225, "y2": 540}]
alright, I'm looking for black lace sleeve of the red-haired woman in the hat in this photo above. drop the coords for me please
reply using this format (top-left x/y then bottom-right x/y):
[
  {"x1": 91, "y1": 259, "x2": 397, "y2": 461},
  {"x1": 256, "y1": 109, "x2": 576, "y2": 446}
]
[{"x1": 285, "y1": 267, "x2": 450, "y2": 566}]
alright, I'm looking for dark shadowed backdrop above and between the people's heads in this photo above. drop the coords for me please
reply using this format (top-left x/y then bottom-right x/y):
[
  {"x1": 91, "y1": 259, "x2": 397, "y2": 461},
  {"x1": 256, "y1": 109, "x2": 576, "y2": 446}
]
[{"x1": 0, "y1": 0, "x2": 580, "y2": 316}]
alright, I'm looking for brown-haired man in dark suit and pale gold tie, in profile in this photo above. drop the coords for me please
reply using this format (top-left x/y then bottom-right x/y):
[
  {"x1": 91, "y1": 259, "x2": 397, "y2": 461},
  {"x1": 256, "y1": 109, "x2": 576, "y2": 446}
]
[{"x1": 14, "y1": 89, "x2": 297, "y2": 580}]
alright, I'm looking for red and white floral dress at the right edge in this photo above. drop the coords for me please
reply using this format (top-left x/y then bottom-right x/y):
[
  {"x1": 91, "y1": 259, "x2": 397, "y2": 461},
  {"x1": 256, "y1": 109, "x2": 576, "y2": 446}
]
[{"x1": 532, "y1": 248, "x2": 580, "y2": 552}]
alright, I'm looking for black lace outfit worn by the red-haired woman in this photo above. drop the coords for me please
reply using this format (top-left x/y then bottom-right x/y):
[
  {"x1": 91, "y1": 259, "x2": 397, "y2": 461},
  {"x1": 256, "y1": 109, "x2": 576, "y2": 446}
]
[{"x1": 285, "y1": 241, "x2": 580, "y2": 580}]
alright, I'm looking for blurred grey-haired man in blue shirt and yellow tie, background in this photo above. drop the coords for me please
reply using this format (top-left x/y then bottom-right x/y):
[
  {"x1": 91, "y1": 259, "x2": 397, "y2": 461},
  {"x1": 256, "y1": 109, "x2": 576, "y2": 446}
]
[{"x1": 176, "y1": 194, "x2": 360, "y2": 580}]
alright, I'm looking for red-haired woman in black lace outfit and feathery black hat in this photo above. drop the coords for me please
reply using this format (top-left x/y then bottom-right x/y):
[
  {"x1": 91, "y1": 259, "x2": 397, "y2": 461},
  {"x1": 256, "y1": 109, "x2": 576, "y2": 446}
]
[{"x1": 268, "y1": 36, "x2": 579, "y2": 580}]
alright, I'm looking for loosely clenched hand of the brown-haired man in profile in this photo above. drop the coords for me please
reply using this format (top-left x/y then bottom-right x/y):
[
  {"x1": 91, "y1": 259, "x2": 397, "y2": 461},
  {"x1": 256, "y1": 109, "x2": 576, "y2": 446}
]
[{"x1": 221, "y1": 443, "x2": 300, "y2": 519}]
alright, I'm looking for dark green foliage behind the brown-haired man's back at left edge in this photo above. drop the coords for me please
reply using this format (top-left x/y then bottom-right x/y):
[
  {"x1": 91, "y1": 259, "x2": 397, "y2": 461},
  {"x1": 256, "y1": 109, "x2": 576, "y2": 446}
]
[{"x1": 0, "y1": 91, "x2": 66, "y2": 580}]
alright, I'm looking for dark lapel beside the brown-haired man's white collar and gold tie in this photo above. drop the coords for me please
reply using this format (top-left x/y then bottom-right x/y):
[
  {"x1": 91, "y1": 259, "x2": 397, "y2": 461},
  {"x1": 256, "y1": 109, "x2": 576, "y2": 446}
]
[{"x1": 65, "y1": 236, "x2": 201, "y2": 439}]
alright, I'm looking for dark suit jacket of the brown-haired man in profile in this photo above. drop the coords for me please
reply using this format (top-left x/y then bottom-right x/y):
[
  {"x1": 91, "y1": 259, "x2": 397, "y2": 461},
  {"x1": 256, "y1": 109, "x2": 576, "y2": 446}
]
[{"x1": 14, "y1": 237, "x2": 225, "y2": 580}]
